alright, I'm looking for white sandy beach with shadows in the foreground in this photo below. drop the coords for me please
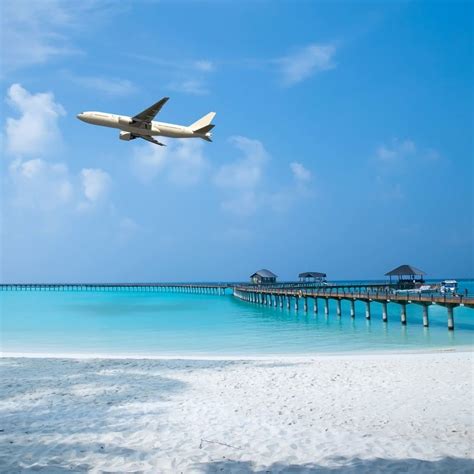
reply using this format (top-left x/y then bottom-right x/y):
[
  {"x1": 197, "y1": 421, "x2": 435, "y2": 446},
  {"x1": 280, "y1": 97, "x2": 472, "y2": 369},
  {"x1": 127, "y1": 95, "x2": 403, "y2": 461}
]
[{"x1": 0, "y1": 352, "x2": 474, "y2": 473}]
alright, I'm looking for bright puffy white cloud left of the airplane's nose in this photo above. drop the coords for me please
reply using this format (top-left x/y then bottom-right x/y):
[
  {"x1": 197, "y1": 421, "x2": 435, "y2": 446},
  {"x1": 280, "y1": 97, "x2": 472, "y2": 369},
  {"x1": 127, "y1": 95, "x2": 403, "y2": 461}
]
[{"x1": 5, "y1": 84, "x2": 66, "y2": 156}]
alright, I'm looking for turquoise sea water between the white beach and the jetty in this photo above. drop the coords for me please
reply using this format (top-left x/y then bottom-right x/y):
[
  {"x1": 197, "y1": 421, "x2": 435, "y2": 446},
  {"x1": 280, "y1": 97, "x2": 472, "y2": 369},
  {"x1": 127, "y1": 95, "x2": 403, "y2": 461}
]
[{"x1": 0, "y1": 280, "x2": 474, "y2": 356}]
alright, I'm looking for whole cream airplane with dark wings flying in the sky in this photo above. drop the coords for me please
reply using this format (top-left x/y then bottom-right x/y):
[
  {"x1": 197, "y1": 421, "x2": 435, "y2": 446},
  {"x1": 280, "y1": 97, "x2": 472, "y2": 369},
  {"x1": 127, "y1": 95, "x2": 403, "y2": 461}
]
[{"x1": 77, "y1": 97, "x2": 216, "y2": 146}]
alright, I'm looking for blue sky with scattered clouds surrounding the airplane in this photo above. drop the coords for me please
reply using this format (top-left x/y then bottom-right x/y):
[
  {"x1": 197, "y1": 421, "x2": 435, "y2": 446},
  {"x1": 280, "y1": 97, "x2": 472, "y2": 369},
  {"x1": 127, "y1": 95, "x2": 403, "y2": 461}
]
[{"x1": 0, "y1": 0, "x2": 474, "y2": 281}]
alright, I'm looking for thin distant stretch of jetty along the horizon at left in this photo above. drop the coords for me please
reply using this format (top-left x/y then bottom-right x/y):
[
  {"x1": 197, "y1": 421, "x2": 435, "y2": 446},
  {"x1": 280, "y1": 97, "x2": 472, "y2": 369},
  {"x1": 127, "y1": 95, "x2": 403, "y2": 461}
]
[{"x1": 0, "y1": 283, "x2": 230, "y2": 295}]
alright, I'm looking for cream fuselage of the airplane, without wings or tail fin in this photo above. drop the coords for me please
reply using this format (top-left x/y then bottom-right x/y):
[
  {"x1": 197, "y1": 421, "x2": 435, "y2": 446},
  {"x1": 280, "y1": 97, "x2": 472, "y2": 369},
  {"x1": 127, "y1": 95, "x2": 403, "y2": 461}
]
[{"x1": 77, "y1": 112, "x2": 198, "y2": 138}]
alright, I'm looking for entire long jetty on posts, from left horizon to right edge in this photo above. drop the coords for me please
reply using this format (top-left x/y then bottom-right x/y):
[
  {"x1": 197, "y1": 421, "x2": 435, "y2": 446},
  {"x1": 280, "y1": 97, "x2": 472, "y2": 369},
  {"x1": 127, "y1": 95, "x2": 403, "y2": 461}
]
[{"x1": 0, "y1": 277, "x2": 474, "y2": 331}]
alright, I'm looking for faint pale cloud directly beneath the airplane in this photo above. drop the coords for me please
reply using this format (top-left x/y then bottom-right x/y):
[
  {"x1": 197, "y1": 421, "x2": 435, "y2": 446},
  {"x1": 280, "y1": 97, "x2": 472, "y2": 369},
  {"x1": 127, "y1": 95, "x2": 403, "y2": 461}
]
[{"x1": 132, "y1": 139, "x2": 207, "y2": 186}]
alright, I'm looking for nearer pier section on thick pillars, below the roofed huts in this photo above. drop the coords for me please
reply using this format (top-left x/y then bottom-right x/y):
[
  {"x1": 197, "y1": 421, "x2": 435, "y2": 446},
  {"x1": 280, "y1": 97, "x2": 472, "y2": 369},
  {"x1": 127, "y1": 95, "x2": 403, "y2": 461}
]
[{"x1": 234, "y1": 285, "x2": 474, "y2": 331}]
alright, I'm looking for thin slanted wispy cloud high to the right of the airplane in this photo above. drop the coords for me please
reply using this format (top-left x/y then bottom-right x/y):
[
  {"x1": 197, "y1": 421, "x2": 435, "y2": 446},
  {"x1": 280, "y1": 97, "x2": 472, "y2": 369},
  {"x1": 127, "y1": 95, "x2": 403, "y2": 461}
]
[{"x1": 275, "y1": 43, "x2": 336, "y2": 86}]
